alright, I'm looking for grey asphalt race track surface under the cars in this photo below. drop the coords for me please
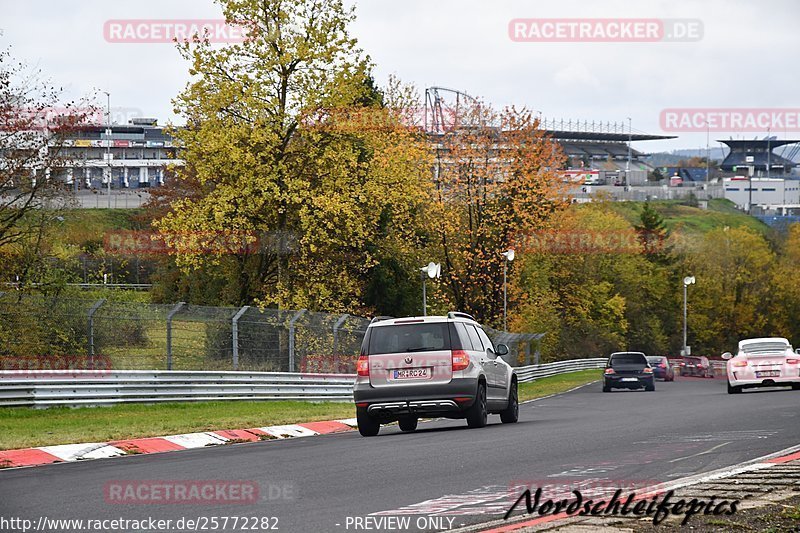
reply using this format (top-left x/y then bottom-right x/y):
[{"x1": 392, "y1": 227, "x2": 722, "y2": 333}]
[{"x1": 0, "y1": 377, "x2": 800, "y2": 532}]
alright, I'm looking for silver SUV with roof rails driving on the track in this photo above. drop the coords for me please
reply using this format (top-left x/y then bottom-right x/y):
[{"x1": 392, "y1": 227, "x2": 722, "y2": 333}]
[{"x1": 353, "y1": 313, "x2": 519, "y2": 437}]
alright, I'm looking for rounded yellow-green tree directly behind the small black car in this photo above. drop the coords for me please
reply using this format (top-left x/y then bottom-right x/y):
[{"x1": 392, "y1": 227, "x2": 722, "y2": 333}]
[{"x1": 515, "y1": 201, "x2": 673, "y2": 360}]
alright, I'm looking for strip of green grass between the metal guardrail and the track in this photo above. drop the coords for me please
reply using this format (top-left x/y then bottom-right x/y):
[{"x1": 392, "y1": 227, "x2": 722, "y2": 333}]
[{"x1": 0, "y1": 370, "x2": 600, "y2": 450}]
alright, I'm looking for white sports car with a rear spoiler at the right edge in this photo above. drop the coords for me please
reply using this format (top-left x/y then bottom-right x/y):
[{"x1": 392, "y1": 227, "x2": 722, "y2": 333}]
[{"x1": 722, "y1": 337, "x2": 800, "y2": 394}]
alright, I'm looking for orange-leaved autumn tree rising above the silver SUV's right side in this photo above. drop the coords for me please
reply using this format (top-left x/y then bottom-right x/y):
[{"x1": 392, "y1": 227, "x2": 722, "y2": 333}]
[{"x1": 430, "y1": 102, "x2": 568, "y2": 324}]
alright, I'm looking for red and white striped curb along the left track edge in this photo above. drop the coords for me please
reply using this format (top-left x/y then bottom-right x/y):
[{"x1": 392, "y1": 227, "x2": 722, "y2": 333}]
[{"x1": 0, "y1": 418, "x2": 357, "y2": 468}]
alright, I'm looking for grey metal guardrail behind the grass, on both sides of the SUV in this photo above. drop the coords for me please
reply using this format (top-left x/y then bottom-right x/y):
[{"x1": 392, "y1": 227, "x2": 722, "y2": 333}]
[{"x1": 0, "y1": 358, "x2": 606, "y2": 407}]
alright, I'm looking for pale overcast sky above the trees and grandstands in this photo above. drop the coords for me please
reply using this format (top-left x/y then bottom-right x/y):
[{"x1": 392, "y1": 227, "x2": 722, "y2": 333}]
[{"x1": 0, "y1": 0, "x2": 800, "y2": 151}]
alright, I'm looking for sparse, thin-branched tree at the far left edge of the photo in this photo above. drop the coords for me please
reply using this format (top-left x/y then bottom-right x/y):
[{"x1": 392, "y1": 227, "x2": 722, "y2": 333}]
[{"x1": 0, "y1": 50, "x2": 95, "y2": 289}]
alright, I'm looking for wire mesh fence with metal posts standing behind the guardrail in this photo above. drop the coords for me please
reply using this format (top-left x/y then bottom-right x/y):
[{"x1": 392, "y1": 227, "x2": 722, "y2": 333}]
[{"x1": 0, "y1": 291, "x2": 542, "y2": 374}]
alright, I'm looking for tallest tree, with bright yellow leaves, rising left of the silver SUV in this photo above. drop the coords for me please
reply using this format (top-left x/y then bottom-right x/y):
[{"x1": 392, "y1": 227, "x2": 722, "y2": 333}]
[{"x1": 156, "y1": 0, "x2": 430, "y2": 312}]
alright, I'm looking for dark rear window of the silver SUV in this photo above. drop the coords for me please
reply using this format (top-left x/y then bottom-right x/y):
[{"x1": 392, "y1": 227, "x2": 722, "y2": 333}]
[{"x1": 369, "y1": 322, "x2": 451, "y2": 355}]
